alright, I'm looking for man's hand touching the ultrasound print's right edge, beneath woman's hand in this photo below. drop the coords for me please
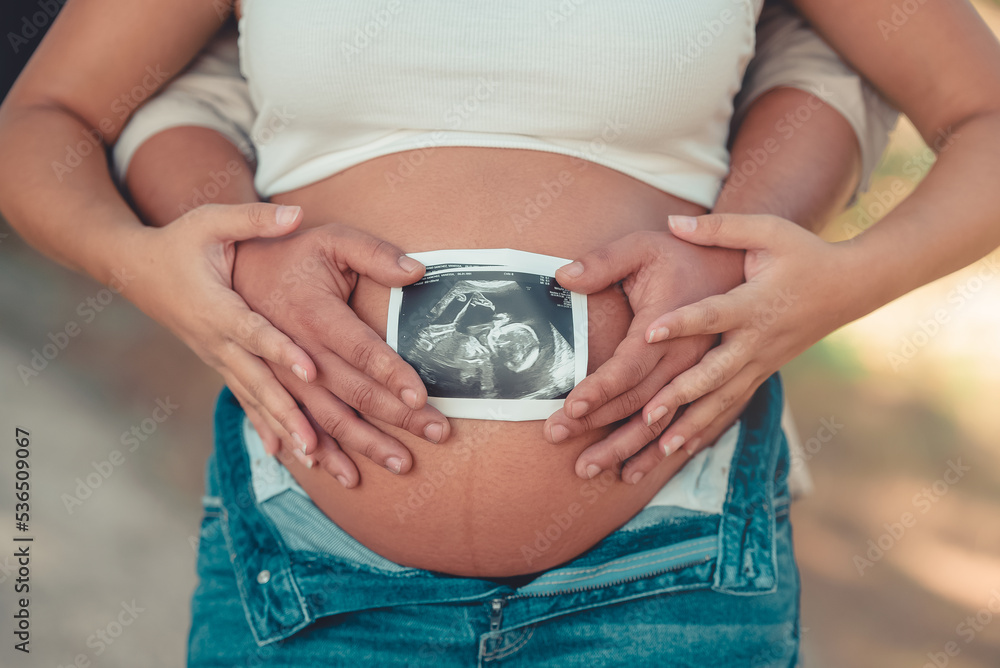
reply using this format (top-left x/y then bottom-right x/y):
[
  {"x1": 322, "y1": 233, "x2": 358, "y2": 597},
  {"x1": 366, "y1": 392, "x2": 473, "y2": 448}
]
[{"x1": 545, "y1": 232, "x2": 743, "y2": 483}]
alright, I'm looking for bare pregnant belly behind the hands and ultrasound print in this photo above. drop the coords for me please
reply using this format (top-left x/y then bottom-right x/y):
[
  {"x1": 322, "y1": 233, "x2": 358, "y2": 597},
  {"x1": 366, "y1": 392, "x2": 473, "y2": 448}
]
[{"x1": 272, "y1": 148, "x2": 716, "y2": 577}]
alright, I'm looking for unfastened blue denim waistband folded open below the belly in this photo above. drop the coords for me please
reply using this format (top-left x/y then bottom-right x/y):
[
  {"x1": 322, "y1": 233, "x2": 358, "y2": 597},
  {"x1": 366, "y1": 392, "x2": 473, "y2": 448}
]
[{"x1": 206, "y1": 375, "x2": 788, "y2": 645}]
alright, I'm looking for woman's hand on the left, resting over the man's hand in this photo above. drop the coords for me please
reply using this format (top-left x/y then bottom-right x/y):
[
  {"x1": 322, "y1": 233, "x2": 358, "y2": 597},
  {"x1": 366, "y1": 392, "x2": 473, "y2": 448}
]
[{"x1": 127, "y1": 203, "x2": 317, "y2": 464}]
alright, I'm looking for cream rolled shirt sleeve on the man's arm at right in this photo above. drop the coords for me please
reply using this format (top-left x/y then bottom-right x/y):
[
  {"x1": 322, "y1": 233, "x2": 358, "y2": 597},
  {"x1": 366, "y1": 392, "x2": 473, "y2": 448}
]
[{"x1": 733, "y1": 0, "x2": 898, "y2": 194}]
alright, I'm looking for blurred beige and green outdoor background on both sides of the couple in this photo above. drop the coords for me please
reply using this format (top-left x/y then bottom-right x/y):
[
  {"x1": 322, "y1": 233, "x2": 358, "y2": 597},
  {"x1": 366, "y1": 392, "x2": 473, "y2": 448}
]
[{"x1": 0, "y1": 2, "x2": 1000, "y2": 668}]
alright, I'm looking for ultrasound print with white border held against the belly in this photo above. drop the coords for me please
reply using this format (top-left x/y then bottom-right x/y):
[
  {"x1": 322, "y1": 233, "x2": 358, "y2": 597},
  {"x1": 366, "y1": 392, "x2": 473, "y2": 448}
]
[{"x1": 387, "y1": 249, "x2": 587, "y2": 420}]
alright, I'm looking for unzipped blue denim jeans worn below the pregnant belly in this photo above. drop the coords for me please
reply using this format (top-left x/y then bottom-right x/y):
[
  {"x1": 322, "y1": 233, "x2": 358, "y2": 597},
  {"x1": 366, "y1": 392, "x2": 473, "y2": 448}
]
[{"x1": 188, "y1": 376, "x2": 799, "y2": 668}]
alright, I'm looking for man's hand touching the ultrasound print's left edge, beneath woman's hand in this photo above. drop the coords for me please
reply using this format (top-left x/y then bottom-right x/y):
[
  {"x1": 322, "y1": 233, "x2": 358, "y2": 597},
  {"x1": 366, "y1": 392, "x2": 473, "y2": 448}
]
[{"x1": 233, "y1": 219, "x2": 452, "y2": 487}]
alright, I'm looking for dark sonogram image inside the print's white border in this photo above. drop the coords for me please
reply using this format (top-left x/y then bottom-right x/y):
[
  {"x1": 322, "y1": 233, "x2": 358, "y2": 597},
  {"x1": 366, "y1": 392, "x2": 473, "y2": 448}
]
[{"x1": 397, "y1": 267, "x2": 576, "y2": 399}]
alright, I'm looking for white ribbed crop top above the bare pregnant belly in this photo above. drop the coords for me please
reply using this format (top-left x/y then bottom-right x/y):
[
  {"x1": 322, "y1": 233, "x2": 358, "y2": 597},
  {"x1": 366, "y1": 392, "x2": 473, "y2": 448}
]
[{"x1": 239, "y1": 0, "x2": 763, "y2": 207}]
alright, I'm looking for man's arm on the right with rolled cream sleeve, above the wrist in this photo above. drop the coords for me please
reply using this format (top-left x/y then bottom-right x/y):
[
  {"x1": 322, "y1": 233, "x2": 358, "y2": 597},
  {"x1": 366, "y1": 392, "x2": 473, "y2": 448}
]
[{"x1": 714, "y1": 0, "x2": 899, "y2": 227}]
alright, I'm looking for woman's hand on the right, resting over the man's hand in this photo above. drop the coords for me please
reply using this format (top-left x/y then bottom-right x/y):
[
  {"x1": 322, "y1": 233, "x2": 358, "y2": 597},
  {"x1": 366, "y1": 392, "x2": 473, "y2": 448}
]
[{"x1": 631, "y1": 214, "x2": 866, "y2": 475}]
